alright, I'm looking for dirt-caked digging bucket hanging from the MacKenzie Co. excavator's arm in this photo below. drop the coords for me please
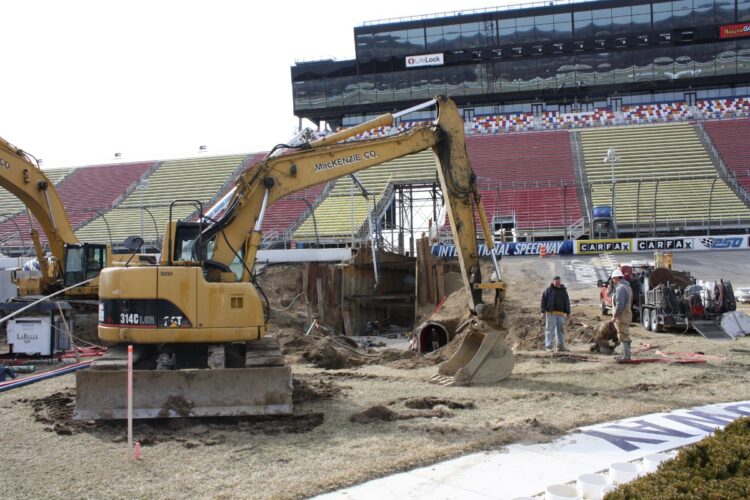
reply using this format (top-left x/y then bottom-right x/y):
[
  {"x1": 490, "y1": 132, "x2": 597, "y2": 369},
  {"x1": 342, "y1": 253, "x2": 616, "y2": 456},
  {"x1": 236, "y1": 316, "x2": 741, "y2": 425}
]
[{"x1": 430, "y1": 321, "x2": 515, "y2": 385}]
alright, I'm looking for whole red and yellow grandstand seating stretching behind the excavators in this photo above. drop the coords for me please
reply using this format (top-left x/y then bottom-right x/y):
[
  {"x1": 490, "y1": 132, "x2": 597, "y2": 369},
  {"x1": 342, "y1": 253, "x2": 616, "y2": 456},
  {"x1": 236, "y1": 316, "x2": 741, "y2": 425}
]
[{"x1": 0, "y1": 97, "x2": 750, "y2": 253}]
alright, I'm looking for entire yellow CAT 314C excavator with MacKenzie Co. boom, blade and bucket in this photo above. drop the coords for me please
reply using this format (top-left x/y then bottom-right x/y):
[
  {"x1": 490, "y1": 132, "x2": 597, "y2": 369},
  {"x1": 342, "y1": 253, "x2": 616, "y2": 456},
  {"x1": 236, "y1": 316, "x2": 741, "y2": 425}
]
[{"x1": 75, "y1": 96, "x2": 513, "y2": 419}]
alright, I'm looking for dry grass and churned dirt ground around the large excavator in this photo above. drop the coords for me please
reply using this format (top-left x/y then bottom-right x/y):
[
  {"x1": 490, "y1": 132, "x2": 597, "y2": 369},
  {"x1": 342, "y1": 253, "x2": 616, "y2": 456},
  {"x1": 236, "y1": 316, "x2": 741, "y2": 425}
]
[{"x1": 0, "y1": 261, "x2": 750, "y2": 498}]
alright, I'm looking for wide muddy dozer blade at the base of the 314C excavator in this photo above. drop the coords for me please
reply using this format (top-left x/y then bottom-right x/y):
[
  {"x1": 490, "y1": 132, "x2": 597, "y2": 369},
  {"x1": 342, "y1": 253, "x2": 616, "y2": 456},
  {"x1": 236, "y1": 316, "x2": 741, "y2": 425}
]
[{"x1": 73, "y1": 366, "x2": 292, "y2": 420}]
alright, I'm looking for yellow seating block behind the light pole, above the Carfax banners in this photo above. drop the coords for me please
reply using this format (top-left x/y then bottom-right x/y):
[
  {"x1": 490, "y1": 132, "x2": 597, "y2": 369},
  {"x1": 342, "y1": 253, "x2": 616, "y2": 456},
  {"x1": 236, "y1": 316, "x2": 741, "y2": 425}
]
[{"x1": 580, "y1": 122, "x2": 750, "y2": 227}]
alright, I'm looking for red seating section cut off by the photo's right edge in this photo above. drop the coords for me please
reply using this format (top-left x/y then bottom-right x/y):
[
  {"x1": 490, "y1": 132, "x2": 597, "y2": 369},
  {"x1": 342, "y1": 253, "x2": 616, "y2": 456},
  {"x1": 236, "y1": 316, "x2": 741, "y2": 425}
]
[{"x1": 703, "y1": 119, "x2": 750, "y2": 192}]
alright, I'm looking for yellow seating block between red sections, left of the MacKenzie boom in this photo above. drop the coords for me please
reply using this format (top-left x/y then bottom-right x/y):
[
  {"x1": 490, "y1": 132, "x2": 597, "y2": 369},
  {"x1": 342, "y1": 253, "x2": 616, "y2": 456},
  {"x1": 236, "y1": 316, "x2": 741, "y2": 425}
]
[{"x1": 76, "y1": 155, "x2": 249, "y2": 244}]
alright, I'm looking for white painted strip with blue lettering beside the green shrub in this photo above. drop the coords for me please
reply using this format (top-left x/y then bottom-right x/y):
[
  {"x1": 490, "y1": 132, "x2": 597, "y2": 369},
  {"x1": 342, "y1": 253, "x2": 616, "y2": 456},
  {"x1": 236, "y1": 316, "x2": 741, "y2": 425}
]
[{"x1": 315, "y1": 401, "x2": 750, "y2": 500}]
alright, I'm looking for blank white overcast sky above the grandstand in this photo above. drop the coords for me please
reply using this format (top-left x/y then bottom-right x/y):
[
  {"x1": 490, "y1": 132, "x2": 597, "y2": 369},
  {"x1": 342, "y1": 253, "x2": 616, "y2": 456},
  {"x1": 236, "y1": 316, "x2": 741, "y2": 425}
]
[{"x1": 0, "y1": 0, "x2": 519, "y2": 168}]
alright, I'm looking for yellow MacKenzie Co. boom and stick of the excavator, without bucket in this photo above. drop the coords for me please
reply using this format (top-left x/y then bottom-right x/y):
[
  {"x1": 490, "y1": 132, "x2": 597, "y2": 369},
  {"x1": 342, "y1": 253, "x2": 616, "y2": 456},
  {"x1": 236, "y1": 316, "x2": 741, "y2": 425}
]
[{"x1": 203, "y1": 97, "x2": 500, "y2": 311}]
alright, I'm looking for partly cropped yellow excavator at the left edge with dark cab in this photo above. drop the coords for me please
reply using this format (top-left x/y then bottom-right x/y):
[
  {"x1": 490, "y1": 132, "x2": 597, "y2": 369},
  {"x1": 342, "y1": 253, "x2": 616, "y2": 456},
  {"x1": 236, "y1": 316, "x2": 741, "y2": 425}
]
[{"x1": 0, "y1": 138, "x2": 112, "y2": 299}]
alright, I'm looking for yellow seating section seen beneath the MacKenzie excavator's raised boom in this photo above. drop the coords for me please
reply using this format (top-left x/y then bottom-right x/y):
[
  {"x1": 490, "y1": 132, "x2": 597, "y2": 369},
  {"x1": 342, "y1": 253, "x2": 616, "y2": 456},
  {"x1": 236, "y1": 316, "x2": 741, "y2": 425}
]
[{"x1": 294, "y1": 150, "x2": 437, "y2": 240}]
